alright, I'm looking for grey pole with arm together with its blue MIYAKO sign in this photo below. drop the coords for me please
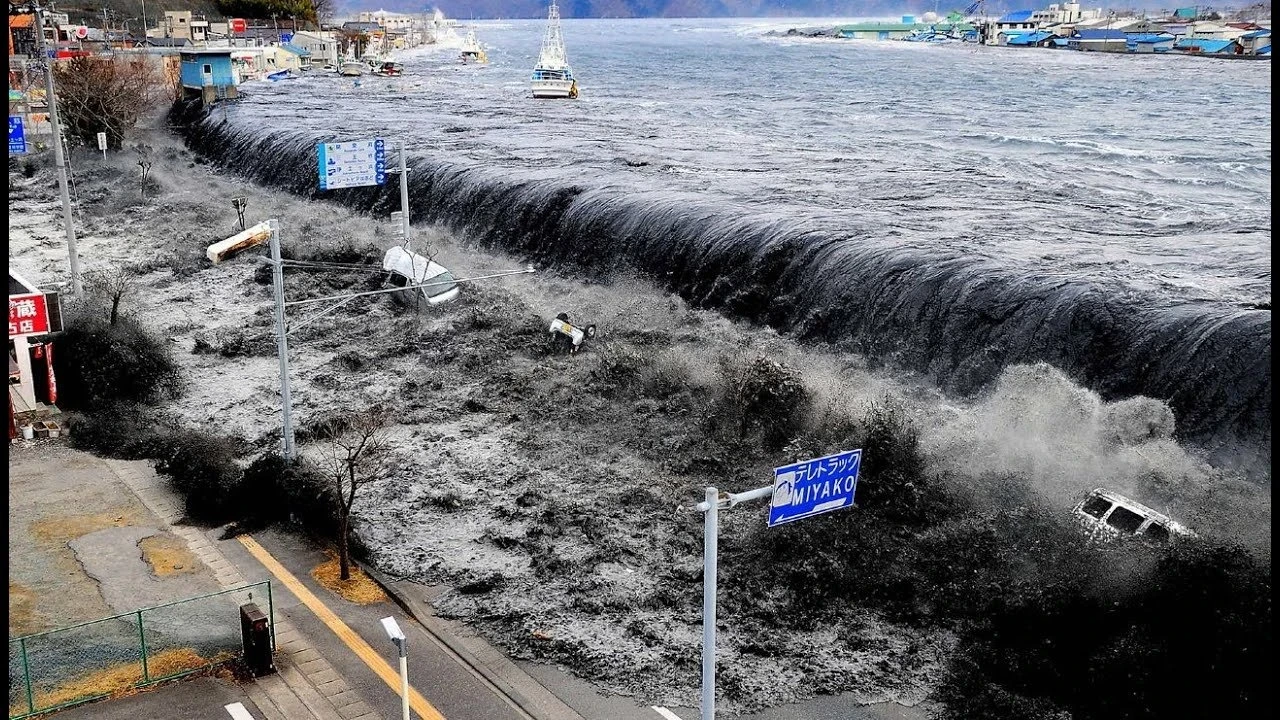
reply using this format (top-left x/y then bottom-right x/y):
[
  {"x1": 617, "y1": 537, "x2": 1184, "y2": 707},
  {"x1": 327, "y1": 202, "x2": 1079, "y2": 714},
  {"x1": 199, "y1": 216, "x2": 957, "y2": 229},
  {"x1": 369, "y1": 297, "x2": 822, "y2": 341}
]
[{"x1": 696, "y1": 450, "x2": 863, "y2": 720}]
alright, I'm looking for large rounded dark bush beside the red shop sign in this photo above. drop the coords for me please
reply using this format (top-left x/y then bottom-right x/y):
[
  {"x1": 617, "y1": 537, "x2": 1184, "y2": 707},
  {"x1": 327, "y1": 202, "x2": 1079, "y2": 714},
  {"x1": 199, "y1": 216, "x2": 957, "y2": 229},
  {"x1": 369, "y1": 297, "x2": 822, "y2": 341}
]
[{"x1": 54, "y1": 307, "x2": 182, "y2": 411}]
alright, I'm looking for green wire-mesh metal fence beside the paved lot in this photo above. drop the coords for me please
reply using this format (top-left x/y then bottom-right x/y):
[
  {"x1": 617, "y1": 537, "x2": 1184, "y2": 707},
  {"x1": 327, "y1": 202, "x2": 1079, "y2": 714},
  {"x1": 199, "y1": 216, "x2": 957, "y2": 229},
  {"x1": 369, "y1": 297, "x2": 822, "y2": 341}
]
[{"x1": 9, "y1": 580, "x2": 275, "y2": 720}]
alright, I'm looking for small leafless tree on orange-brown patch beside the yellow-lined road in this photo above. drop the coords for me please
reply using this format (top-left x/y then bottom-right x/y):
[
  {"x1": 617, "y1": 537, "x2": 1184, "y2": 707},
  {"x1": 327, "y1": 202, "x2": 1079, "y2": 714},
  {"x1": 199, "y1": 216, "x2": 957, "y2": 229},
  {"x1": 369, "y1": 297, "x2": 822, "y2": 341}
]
[{"x1": 317, "y1": 407, "x2": 390, "y2": 580}]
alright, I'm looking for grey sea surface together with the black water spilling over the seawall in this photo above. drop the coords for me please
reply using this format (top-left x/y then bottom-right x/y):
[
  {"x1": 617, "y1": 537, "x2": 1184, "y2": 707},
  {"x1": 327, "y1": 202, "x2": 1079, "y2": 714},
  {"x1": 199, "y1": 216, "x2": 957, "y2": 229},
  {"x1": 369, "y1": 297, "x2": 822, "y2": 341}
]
[{"x1": 177, "y1": 20, "x2": 1271, "y2": 474}]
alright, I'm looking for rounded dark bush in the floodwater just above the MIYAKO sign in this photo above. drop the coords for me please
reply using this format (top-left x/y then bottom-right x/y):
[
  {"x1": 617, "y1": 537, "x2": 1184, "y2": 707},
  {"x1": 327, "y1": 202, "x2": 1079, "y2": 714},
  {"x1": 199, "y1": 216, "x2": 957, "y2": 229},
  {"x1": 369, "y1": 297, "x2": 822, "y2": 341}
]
[{"x1": 718, "y1": 355, "x2": 810, "y2": 451}]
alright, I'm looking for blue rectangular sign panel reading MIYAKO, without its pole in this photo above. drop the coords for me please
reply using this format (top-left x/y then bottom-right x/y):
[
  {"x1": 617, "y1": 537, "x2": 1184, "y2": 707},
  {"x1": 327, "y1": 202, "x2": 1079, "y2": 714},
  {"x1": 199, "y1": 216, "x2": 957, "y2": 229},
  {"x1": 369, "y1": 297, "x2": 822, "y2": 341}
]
[{"x1": 769, "y1": 450, "x2": 863, "y2": 528}]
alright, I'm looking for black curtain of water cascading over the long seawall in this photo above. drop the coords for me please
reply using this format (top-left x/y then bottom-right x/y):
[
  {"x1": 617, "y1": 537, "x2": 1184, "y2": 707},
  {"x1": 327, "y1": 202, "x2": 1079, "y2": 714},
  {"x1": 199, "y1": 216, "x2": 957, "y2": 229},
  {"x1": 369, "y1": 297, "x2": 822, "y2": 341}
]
[{"x1": 174, "y1": 105, "x2": 1271, "y2": 466}]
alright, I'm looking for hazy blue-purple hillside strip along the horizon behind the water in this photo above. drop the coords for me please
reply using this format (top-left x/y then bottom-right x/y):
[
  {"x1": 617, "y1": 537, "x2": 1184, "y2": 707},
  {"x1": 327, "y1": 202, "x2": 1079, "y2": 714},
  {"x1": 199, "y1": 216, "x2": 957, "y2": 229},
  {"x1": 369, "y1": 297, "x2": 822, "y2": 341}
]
[{"x1": 338, "y1": 0, "x2": 931, "y2": 20}]
